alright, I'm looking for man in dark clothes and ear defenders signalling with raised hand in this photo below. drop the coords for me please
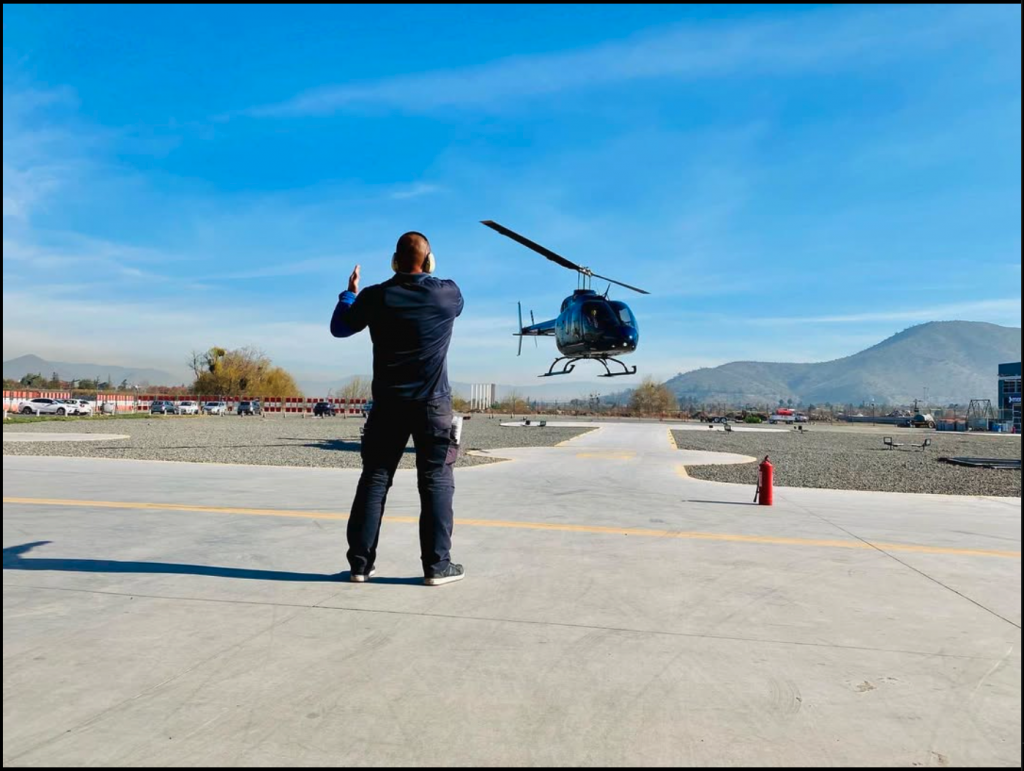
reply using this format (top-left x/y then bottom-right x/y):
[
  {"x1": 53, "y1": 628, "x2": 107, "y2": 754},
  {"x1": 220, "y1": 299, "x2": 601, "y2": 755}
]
[{"x1": 331, "y1": 232, "x2": 465, "y2": 587}]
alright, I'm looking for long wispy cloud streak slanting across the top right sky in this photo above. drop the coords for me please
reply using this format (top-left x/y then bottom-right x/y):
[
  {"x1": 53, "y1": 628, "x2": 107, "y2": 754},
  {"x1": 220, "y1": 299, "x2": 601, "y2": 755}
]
[{"x1": 245, "y1": 6, "x2": 1007, "y2": 118}]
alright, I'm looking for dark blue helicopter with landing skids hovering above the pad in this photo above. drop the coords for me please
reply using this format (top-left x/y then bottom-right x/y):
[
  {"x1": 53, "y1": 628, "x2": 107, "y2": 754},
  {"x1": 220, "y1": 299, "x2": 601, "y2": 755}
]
[{"x1": 481, "y1": 220, "x2": 650, "y2": 378}]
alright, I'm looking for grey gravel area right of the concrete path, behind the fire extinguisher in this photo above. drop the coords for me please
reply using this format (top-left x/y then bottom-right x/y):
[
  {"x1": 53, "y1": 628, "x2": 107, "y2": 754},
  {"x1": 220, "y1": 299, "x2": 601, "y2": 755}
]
[{"x1": 673, "y1": 427, "x2": 1021, "y2": 498}]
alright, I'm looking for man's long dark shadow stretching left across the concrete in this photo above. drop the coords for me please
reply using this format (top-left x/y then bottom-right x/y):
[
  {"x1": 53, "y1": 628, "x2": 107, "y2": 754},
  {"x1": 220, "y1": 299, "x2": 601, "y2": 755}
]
[{"x1": 3, "y1": 541, "x2": 423, "y2": 586}]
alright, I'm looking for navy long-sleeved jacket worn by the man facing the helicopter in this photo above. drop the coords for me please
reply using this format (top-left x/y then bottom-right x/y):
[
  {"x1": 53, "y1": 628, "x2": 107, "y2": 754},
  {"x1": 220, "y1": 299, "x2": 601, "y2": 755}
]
[{"x1": 331, "y1": 273, "x2": 464, "y2": 401}]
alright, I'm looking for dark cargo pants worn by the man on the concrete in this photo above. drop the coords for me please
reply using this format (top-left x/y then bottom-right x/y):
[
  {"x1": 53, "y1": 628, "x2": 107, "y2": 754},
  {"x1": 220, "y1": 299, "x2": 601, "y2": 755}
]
[{"x1": 348, "y1": 397, "x2": 459, "y2": 575}]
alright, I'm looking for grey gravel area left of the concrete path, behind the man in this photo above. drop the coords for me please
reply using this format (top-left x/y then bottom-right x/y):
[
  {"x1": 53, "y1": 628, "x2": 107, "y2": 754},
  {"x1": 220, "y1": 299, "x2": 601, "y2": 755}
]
[{"x1": 3, "y1": 416, "x2": 590, "y2": 468}]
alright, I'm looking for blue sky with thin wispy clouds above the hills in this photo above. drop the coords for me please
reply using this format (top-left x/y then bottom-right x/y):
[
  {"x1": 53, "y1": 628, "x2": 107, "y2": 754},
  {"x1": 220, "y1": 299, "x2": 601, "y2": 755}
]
[{"x1": 3, "y1": 5, "x2": 1021, "y2": 387}]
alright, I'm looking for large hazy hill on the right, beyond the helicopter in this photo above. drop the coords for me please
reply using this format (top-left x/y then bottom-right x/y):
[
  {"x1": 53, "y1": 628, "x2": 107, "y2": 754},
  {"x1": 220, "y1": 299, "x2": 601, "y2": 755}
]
[{"x1": 667, "y1": 322, "x2": 1021, "y2": 404}]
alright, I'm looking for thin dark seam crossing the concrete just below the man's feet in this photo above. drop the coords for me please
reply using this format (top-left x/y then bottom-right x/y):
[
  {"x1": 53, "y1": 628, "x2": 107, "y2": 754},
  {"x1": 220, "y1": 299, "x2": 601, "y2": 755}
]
[{"x1": 3, "y1": 584, "x2": 1015, "y2": 663}]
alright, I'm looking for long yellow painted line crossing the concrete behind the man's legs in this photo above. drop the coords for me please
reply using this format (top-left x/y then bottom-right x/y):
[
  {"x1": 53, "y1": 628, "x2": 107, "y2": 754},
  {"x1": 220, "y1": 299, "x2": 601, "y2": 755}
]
[{"x1": 3, "y1": 498, "x2": 1021, "y2": 560}]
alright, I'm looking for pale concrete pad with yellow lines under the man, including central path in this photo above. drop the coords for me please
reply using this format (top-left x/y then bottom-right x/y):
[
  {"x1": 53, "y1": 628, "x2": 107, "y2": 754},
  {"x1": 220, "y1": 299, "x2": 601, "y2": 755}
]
[{"x1": 3, "y1": 424, "x2": 1021, "y2": 767}]
